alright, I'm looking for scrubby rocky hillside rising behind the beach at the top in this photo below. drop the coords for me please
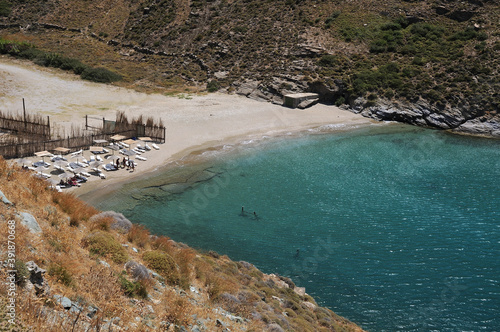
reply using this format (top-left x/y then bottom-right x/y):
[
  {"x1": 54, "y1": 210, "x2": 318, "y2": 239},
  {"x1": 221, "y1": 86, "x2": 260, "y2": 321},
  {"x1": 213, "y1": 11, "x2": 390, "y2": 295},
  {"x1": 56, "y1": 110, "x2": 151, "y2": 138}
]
[{"x1": 0, "y1": 0, "x2": 500, "y2": 136}]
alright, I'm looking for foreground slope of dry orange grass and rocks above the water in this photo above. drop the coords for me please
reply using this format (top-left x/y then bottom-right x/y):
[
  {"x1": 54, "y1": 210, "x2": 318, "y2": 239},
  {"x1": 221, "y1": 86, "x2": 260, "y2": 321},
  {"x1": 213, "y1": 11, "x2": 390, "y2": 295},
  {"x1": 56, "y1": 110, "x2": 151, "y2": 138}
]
[{"x1": 0, "y1": 157, "x2": 362, "y2": 332}]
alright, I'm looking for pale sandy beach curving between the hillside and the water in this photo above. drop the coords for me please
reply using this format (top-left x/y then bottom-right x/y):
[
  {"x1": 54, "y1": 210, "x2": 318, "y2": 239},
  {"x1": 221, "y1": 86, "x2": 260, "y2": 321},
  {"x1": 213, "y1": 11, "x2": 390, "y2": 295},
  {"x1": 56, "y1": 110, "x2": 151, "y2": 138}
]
[{"x1": 0, "y1": 57, "x2": 374, "y2": 200}]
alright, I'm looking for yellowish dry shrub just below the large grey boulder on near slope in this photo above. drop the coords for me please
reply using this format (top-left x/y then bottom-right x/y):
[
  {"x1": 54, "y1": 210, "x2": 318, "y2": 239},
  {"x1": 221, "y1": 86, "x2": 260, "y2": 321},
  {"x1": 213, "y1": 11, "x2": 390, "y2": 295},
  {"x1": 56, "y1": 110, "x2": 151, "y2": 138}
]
[{"x1": 82, "y1": 231, "x2": 128, "y2": 264}]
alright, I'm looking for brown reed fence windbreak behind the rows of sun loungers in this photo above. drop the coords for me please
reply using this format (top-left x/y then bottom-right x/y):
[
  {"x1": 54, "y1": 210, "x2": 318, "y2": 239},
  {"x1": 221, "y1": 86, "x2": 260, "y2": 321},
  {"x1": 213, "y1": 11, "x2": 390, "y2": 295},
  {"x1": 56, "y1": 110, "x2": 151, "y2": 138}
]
[{"x1": 0, "y1": 112, "x2": 166, "y2": 158}]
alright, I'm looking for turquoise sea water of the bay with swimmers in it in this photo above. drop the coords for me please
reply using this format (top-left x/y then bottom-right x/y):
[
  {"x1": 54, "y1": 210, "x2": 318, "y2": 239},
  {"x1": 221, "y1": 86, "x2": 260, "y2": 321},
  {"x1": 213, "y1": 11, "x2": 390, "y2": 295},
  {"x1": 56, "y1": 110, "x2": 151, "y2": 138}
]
[{"x1": 94, "y1": 126, "x2": 500, "y2": 331}]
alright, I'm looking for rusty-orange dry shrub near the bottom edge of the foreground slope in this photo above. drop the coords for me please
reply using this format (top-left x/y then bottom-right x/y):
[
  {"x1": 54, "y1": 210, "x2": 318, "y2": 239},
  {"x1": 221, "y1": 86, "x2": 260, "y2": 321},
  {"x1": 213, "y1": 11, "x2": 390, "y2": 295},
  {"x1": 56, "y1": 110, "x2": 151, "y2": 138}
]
[{"x1": 160, "y1": 290, "x2": 194, "y2": 326}]
